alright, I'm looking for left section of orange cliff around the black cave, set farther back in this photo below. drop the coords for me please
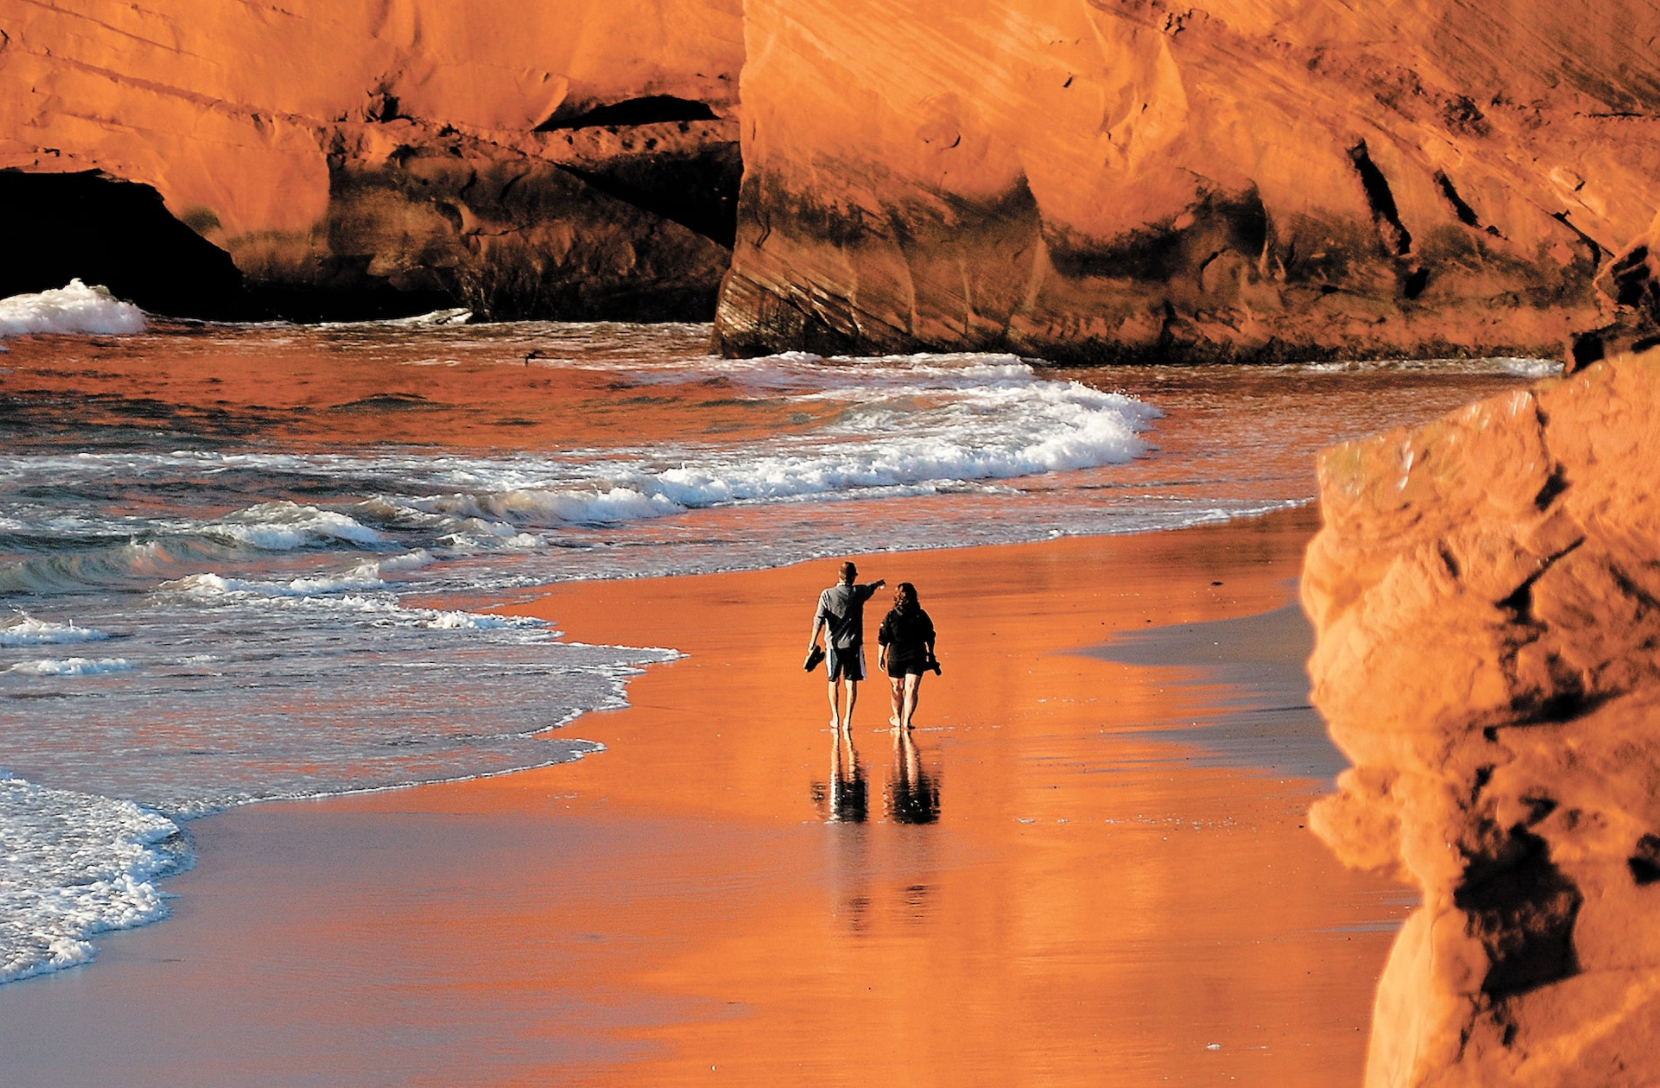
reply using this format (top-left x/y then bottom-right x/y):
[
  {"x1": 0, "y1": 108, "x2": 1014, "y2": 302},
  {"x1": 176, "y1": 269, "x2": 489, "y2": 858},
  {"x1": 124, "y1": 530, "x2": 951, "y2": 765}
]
[{"x1": 0, "y1": 0, "x2": 742, "y2": 319}]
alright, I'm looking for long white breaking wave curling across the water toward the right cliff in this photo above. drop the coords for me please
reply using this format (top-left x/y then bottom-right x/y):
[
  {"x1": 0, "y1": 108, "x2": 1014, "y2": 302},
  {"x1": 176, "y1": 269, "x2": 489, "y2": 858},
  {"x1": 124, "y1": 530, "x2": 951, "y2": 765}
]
[{"x1": 0, "y1": 352, "x2": 1162, "y2": 558}]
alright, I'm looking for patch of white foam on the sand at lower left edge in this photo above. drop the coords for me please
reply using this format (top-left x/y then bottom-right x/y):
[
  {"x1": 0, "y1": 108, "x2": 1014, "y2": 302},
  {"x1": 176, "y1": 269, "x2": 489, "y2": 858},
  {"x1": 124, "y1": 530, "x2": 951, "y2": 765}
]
[{"x1": 0, "y1": 777, "x2": 189, "y2": 983}]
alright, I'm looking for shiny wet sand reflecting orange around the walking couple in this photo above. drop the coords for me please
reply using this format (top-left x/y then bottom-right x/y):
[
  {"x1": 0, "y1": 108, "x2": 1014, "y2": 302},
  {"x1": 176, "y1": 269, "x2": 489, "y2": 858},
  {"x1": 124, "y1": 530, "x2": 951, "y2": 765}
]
[{"x1": 0, "y1": 512, "x2": 1409, "y2": 1088}]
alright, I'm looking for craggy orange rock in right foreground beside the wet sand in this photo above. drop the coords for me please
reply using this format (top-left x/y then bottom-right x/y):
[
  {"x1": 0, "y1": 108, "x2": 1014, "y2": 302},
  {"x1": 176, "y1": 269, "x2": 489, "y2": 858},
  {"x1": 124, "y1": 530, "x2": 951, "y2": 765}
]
[{"x1": 1303, "y1": 350, "x2": 1660, "y2": 1088}]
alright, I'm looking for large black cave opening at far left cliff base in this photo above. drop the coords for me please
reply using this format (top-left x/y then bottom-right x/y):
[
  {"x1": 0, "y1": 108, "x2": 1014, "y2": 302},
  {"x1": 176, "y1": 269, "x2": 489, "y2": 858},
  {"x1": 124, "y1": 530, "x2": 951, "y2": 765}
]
[{"x1": 0, "y1": 169, "x2": 242, "y2": 317}]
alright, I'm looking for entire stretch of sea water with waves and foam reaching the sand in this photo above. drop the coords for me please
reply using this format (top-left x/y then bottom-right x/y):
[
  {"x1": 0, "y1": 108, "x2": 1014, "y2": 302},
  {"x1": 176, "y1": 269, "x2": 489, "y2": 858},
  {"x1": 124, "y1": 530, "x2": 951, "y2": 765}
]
[{"x1": 0, "y1": 282, "x2": 1550, "y2": 982}]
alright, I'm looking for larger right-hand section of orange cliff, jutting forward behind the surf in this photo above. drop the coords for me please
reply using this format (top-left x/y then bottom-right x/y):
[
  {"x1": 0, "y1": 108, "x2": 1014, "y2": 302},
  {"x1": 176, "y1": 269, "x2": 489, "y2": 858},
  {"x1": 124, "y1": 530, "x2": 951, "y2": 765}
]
[{"x1": 717, "y1": 0, "x2": 1660, "y2": 362}]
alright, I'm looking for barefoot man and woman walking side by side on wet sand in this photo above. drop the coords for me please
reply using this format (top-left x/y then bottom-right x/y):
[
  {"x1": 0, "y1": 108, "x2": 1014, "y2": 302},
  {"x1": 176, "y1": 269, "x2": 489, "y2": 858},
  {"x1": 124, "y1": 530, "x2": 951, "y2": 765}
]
[{"x1": 807, "y1": 561, "x2": 940, "y2": 729}]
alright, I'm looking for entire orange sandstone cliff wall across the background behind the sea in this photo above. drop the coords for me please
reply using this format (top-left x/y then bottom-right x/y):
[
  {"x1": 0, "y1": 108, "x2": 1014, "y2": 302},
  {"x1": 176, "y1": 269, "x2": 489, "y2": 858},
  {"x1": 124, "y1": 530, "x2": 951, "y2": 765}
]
[{"x1": 0, "y1": 0, "x2": 1660, "y2": 347}]
